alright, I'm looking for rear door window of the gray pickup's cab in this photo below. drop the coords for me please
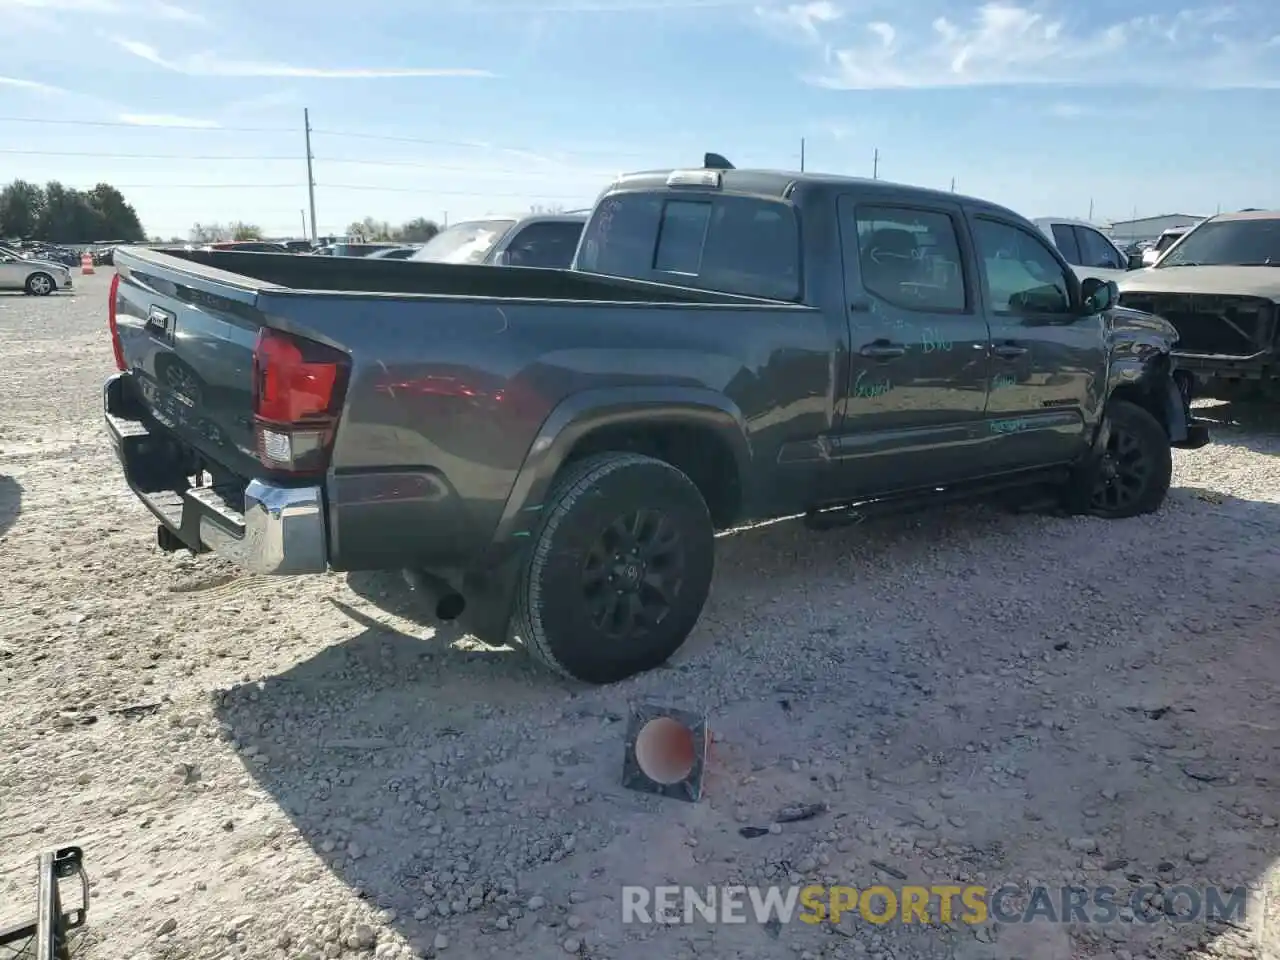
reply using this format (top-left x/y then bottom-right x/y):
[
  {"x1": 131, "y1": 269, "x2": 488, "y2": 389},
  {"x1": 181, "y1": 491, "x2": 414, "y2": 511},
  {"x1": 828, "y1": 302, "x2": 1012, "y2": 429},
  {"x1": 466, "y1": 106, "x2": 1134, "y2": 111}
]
[{"x1": 854, "y1": 206, "x2": 965, "y2": 312}]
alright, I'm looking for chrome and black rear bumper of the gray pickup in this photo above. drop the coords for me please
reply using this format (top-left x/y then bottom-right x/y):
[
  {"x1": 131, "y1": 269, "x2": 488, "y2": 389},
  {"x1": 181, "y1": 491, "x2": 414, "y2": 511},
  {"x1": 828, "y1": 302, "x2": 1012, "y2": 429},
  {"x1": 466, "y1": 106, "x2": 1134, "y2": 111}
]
[{"x1": 102, "y1": 374, "x2": 329, "y2": 575}]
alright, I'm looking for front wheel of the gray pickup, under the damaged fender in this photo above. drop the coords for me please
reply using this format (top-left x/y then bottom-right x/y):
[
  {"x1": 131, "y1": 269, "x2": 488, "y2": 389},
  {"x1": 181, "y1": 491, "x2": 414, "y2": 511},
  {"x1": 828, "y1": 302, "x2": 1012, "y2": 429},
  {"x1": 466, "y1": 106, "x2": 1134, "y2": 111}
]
[{"x1": 1087, "y1": 401, "x2": 1174, "y2": 520}]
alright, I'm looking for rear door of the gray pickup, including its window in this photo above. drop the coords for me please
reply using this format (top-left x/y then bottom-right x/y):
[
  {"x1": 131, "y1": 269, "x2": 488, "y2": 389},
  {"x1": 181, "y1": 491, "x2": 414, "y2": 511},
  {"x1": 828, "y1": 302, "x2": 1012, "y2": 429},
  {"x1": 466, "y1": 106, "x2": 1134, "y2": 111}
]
[{"x1": 836, "y1": 195, "x2": 989, "y2": 497}]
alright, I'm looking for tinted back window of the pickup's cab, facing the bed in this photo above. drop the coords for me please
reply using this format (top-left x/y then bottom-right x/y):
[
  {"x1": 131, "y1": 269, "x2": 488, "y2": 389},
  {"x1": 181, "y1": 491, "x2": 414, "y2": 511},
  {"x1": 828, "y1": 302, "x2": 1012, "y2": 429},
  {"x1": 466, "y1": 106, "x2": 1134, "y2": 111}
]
[{"x1": 577, "y1": 193, "x2": 800, "y2": 300}]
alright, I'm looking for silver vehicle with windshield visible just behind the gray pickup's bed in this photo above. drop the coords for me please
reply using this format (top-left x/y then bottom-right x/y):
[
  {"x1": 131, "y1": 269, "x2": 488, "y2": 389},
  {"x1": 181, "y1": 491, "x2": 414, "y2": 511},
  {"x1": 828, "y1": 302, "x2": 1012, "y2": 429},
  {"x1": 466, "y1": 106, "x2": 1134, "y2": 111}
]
[{"x1": 410, "y1": 210, "x2": 590, "y2": 270}]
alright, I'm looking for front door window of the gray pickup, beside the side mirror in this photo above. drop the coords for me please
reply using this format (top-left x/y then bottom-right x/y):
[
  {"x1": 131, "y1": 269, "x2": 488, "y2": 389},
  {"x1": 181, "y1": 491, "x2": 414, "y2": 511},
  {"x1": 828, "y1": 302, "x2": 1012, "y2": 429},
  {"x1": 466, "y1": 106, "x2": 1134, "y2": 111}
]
[{"x1": 974, "y1": 218, "x2": 1071, "y2": 315}]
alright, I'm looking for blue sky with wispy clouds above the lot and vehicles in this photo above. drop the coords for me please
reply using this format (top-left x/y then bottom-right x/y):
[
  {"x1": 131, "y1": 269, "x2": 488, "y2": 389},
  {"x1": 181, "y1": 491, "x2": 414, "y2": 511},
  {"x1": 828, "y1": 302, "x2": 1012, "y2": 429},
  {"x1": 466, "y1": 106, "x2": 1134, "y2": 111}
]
[{"x1": 0, "y1": 0, "x2": 1280, "y2": 238}]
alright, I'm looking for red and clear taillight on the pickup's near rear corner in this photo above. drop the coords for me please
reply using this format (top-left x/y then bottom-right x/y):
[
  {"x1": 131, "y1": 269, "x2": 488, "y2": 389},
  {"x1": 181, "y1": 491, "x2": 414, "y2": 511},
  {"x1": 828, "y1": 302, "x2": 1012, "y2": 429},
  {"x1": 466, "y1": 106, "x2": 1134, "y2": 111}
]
[{"x1": 253, "y1": 326, "x2": 351, "y2": 474}]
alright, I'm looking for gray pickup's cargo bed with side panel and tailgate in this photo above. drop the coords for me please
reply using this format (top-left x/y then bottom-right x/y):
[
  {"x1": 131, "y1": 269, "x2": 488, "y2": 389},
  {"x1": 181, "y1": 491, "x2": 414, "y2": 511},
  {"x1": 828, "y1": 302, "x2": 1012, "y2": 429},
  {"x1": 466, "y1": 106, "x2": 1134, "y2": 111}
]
[{"x1": 108, "y1": 247, "x2": 835, "y2": 578}]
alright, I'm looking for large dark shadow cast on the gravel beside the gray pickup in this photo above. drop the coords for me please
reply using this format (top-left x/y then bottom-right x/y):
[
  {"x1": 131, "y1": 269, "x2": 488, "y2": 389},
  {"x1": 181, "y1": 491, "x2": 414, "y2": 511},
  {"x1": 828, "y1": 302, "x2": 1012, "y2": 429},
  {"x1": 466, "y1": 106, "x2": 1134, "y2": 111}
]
[{"x1": 218, "y1": 490, "x2": 1280, "y2": 960}]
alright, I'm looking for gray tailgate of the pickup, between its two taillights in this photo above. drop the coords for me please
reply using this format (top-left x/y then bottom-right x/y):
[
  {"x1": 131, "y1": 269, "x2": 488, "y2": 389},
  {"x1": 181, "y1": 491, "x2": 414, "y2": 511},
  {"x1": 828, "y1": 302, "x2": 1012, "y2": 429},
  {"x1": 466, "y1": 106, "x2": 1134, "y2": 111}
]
[{"x1": 115, "y1": 253, "x2": 272, "y2": 477}]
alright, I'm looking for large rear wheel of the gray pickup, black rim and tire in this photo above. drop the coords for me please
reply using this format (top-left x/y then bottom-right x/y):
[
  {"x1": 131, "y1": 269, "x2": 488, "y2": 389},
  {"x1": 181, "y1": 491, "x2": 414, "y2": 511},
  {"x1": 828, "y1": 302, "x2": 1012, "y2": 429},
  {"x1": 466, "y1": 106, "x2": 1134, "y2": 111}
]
[{"x1": 512, "y1": 453, "x2": 716, "y2": 684}]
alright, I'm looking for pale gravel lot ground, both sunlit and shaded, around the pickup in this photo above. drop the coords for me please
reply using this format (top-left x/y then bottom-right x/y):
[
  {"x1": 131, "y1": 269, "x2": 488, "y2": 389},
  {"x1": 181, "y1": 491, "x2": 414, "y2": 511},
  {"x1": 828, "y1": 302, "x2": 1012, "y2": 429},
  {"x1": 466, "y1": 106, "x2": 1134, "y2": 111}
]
[{"x1": 0, "y1": 273, "x2": 1280, "y2": 960}]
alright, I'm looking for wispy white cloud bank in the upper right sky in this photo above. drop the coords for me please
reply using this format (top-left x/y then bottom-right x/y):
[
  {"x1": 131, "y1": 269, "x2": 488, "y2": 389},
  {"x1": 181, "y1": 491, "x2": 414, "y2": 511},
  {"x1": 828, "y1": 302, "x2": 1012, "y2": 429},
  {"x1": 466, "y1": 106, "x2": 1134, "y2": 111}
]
[{"x1": 756, "y1": 0, "x2": 1280, "y2": 90}]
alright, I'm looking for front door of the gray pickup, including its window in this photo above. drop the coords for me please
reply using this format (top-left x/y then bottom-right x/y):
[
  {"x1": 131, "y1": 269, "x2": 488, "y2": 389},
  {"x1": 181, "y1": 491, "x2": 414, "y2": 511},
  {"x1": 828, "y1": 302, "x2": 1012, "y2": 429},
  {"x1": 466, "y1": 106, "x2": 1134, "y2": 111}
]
[{"x1": 970, "y1": 212, "x2": 1106, "y2": 470}]
